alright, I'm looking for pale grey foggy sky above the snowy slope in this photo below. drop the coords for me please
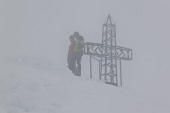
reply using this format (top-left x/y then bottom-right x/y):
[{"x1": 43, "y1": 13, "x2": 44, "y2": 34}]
[{"x1": 0, "y1": 0, "x2": 170, "y2": 105}]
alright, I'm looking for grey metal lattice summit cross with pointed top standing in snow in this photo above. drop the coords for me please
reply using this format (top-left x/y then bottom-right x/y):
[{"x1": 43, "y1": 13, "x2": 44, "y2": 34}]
[{"x1": 84, "y1": 15, "x2": 132, "y2": 86}]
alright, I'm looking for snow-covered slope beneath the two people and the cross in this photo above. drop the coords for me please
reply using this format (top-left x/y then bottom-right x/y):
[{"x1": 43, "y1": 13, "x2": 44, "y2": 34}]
[{"x1": 0, "y1": 56, "x2": 170, "y2": 113}]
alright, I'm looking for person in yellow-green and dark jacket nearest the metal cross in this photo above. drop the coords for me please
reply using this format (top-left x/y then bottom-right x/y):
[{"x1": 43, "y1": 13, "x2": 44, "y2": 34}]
[{"x1": 73, "y1": 31, "x2": 84, "y2": 76}]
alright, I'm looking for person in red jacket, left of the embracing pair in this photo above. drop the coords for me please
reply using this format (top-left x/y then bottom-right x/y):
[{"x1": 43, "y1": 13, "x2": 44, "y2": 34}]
[{"x1": 67, "y1": 35, "x2": 76, "y2": 74}]
